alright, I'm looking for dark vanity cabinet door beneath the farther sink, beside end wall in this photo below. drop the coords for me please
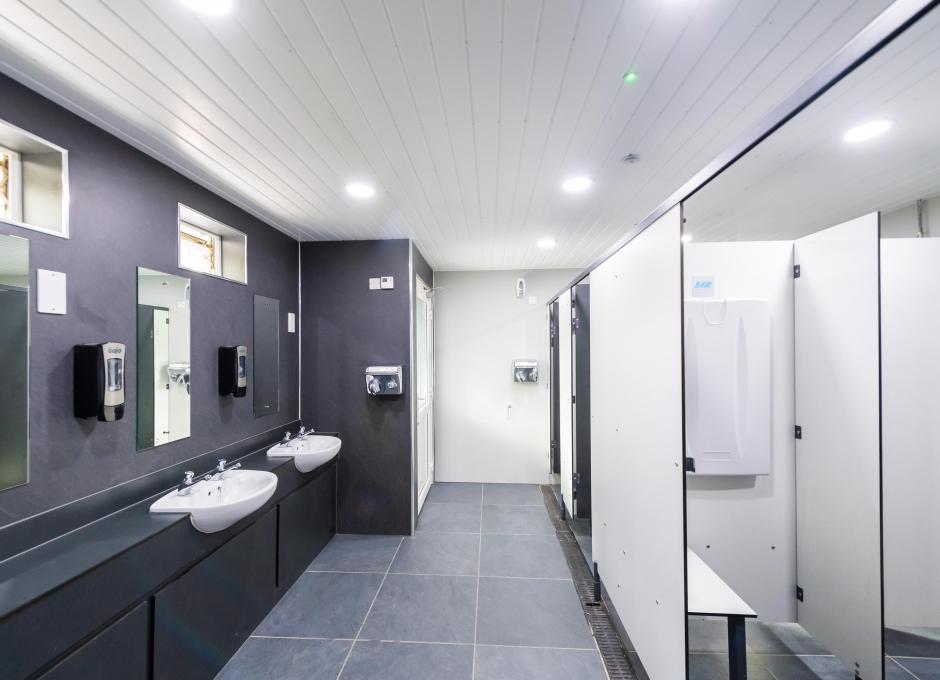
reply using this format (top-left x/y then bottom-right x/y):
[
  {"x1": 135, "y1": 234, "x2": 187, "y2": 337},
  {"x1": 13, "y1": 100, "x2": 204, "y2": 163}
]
[{"x1": 277, "y1": 464, "x2": 336, "y2": 592}]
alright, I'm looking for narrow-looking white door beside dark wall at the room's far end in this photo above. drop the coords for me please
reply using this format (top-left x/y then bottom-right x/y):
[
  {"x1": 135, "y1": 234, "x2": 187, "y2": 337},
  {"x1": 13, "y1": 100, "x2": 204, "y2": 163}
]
[{"x1": 415, "y1": 278, "x2": 434, "y2": 512}]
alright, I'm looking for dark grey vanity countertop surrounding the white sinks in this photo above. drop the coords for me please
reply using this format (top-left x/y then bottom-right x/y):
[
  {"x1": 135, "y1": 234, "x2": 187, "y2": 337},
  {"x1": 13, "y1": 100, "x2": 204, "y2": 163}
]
[{"x1": 0, "y1": 450, "x2": 303, "y2": 621}]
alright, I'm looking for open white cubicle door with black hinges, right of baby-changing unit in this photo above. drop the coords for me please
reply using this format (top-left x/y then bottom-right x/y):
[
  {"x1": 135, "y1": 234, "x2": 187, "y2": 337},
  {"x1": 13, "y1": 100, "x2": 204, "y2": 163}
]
[{"x1": 794, "y1": 213, "x2": 883, "y2": 680}]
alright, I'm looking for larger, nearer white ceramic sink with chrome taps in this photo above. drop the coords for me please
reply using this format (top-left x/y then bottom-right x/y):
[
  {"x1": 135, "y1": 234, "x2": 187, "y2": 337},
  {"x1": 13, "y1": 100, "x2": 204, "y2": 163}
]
[{"x1": 150, "y1": 470, "x2": 277, "y2": 534}]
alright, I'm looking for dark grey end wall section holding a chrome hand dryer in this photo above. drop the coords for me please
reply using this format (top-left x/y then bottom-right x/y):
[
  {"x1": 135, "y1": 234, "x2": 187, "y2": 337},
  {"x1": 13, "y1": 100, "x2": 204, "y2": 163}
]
[{"x1": 300, "y1": 240, "x2": 411, "y2": 534}]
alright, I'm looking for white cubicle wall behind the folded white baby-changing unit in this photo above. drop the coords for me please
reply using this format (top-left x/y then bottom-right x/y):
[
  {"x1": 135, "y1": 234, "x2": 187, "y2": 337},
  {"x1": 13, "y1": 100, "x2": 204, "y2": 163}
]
[{"x1": 683, "y1": 241, "x2": 796, "y2": 621}]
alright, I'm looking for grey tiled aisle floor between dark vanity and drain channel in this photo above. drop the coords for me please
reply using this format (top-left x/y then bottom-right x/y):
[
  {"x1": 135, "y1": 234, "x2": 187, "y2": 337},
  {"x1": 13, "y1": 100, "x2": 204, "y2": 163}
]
[{"x1": 219, "y1": 483, "x2": 607, "y2": 680}]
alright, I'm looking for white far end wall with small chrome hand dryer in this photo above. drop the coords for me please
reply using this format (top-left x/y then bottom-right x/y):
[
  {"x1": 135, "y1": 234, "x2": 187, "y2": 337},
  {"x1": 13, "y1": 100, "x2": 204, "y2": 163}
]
[{"x1": 434, "y1": 269, "x2": 577, "y2": 484}]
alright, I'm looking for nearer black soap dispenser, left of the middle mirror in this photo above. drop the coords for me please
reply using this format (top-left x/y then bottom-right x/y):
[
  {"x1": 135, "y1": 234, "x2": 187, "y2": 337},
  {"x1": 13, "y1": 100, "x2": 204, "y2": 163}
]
[{"x1": 72, "y1": 342, "x2": 127, "y2": 422}]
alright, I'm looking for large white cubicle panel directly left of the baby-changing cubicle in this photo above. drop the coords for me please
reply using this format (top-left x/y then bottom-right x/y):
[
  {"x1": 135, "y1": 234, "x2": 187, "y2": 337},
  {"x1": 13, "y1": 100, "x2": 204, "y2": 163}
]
[{"x1": 591, "y1": 207, "x2": 686, "y2": 680}]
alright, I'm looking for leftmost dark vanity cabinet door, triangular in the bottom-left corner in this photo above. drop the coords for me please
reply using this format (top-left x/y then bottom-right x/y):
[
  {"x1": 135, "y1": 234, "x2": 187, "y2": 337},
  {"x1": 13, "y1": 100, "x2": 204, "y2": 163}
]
[{"x1": 42, "y1": 602, "x2": 150, "y2": 680}]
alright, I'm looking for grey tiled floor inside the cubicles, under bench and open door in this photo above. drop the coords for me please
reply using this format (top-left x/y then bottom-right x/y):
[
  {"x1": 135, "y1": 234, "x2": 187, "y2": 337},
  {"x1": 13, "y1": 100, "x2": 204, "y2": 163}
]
[{"x1": 689, "y1": 617, "x2": 940, "y2": 680}]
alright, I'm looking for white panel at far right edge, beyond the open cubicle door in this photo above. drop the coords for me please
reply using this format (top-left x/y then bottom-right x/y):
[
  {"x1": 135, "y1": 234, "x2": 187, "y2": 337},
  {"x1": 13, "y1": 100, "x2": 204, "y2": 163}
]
[{"x1": 881, "y1": 238, "x2": 940, "y2": 627}]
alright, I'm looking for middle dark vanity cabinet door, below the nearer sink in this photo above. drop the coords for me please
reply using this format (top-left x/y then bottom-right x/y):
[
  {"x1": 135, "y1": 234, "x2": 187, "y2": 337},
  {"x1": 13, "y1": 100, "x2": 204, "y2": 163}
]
[{"x1": 153, "y1": 508, "x2": 277, "y2": 680}]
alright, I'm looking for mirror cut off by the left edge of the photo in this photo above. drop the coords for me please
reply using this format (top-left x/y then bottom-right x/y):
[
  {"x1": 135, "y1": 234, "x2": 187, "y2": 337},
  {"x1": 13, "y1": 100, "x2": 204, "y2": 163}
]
[{"x1": 0, "y1": 236, "x2": 29, "y2": 489}]
